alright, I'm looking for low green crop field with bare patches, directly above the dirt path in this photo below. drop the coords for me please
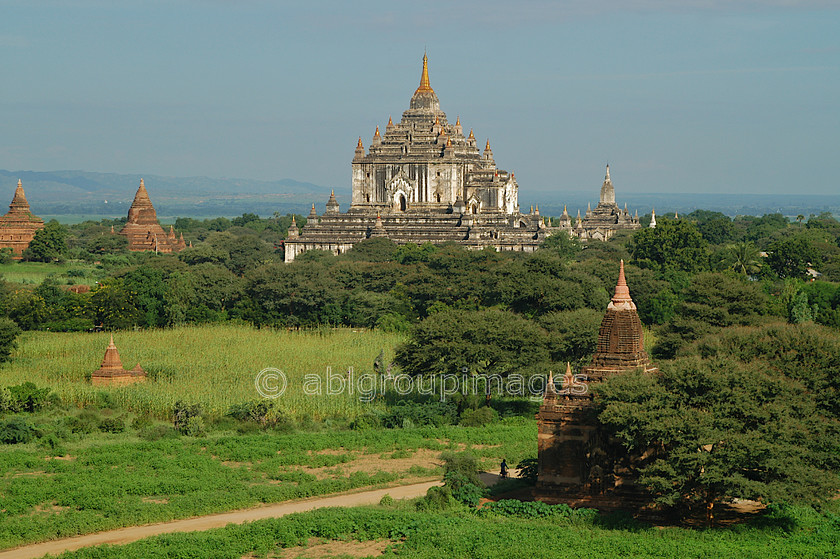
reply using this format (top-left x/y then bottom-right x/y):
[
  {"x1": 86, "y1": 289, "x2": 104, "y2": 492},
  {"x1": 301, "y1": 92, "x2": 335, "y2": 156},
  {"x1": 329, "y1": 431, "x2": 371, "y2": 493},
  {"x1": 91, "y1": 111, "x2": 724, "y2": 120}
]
[{"x1": 0, "y1": 418, "x2": 536, "y2": 549}]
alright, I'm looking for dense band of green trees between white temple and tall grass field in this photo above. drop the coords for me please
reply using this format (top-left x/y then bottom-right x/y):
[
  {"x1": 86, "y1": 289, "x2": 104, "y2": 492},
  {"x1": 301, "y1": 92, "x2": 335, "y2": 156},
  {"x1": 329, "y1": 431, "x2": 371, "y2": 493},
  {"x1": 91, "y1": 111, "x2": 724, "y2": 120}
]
[{"x1": 0, "y1": 210, "x2": 840, "y2": 346}]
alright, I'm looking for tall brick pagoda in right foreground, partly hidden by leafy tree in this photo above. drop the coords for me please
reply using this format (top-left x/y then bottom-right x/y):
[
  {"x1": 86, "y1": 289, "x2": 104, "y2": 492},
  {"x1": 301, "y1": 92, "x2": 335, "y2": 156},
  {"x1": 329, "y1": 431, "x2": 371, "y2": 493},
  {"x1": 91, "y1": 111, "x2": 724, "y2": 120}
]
[{"x1": 536, "y1": 261, "x2": 657, "y2": 506}]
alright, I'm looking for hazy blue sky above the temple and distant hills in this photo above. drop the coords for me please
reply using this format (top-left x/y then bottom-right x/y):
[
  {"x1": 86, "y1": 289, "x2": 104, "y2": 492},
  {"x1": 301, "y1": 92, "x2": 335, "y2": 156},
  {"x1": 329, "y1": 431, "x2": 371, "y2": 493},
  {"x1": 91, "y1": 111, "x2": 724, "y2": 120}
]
[{"x1": 0, "y1": 0, "x2": 840, "y2": 197}]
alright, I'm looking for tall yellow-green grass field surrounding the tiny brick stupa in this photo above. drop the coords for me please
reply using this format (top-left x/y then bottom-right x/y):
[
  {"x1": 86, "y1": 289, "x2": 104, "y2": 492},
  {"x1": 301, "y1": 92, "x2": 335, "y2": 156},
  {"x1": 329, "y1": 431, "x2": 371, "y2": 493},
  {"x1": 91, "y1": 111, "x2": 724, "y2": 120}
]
[{"x1": 0, "y1": 324, "x2": 403, "y2": 420}]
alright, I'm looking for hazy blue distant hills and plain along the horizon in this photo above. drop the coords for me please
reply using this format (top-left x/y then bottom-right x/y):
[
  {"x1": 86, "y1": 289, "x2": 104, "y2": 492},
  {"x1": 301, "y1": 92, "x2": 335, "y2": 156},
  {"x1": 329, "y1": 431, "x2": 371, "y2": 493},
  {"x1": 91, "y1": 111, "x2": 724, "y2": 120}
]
[{"x1": 0, "y1": 169, "x2": 840, "y2": 222}]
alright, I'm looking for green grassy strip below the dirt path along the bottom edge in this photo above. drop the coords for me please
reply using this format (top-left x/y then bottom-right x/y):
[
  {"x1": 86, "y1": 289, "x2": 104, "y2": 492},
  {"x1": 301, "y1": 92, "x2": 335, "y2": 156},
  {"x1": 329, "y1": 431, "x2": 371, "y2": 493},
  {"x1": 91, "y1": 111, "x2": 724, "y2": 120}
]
[{"x1": 42, "y1": 502, "x2": 840, "y2": 559}]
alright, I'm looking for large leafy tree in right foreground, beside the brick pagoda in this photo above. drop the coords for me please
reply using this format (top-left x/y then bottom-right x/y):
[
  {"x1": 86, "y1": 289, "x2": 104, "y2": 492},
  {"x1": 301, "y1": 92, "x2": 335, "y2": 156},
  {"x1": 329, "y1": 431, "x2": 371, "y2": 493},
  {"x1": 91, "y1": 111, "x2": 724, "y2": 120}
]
[{"x1": 598, "y1": 358, "x2": 840, "y2": 520}]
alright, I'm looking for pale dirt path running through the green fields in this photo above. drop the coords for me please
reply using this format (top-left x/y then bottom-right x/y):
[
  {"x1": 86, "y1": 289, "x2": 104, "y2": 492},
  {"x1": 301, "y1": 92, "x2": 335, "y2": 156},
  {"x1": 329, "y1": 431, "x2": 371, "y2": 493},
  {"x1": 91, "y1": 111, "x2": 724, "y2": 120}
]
[{"x1": 0, "y1": 481, "x2": 440, "y2": 559}]
